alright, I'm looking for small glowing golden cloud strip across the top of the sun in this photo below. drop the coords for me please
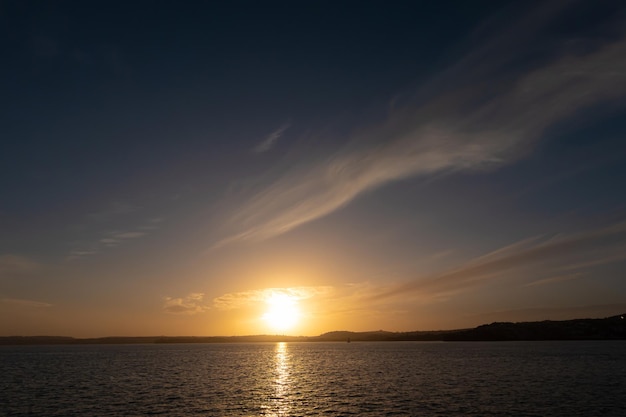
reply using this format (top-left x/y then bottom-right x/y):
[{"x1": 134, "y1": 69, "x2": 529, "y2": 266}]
[{"x1": 213, "y1": 286, "x2": 333, "y2": 310}]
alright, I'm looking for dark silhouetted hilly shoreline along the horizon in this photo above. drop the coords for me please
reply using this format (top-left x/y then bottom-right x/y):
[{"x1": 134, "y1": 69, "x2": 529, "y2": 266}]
[{"x1": 0, "y1": 313, "x2": 626, "y2": 346}]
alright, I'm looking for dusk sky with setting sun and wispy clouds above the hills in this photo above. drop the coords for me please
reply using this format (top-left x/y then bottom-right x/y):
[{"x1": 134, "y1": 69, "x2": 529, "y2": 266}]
[{"x1": 0, "y1": 0, "x2": 626, "y2": 337}]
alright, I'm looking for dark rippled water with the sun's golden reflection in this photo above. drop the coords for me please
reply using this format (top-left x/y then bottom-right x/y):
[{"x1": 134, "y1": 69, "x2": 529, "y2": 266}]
[{"x1": 0, "y1": 341, "x2": 626, "y2": 417}]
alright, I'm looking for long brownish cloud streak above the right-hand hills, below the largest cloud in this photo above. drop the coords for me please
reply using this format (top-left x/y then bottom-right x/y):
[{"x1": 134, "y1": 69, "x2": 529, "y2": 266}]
[{"x1": 372, "y1": 222, "x2": 626, "y2": 299}]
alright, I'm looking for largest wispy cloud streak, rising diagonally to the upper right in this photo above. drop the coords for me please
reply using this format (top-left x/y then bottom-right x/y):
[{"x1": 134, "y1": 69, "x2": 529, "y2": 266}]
[{"x1": 213, "y1": 11, "x2": 626, "y2": 248}]
